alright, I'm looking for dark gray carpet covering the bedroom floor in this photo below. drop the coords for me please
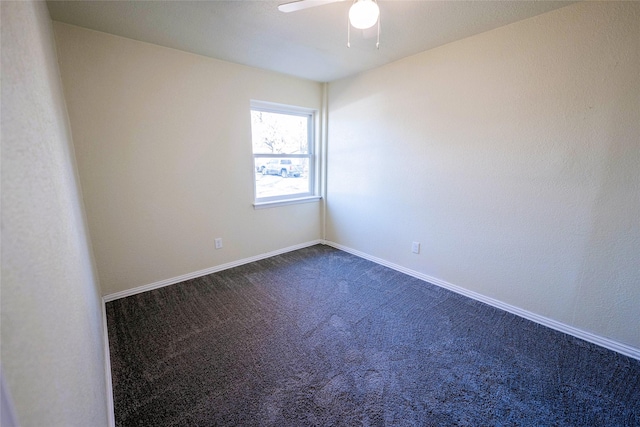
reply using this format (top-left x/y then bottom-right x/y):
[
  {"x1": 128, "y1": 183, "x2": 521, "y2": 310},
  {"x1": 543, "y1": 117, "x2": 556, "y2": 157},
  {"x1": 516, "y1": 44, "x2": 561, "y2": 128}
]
[{"x1": 106, "y1": 245, "x2": 640, "y2": 426}]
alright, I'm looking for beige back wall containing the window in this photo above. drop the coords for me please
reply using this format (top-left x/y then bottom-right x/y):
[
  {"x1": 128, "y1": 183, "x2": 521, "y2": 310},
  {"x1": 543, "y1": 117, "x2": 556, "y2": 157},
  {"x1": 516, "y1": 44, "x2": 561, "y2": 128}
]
[{"x1": 54, "y1": 23, "x2": 322, "y2": 295}]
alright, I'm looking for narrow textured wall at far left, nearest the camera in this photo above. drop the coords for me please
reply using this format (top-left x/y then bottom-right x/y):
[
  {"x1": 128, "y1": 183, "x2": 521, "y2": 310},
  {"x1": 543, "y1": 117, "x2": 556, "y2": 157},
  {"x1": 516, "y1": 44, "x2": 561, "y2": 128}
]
[{"x1": 0, "y1": 1, "x2": 107, "y2": 427}]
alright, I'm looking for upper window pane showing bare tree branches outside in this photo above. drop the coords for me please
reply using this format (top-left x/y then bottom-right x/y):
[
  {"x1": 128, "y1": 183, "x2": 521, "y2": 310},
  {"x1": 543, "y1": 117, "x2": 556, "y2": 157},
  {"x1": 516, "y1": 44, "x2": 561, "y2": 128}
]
[{"x1": 251, "y1": 110, "x2": 309, "y2": 154}]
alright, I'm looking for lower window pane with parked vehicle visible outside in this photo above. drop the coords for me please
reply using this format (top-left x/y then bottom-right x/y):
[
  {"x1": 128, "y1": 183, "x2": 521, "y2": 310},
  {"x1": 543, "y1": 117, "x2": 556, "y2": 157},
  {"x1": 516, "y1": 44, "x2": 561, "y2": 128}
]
[{"x1": 255, "y1": 157, "x2": 309, "y2": 198}]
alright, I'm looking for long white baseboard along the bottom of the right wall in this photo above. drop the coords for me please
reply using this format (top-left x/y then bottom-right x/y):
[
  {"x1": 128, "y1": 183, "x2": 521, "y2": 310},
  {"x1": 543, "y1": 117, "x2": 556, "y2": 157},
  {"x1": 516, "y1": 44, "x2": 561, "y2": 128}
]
[{"x1": 322, "y1": 241, "x2": 640, "y2": 360}]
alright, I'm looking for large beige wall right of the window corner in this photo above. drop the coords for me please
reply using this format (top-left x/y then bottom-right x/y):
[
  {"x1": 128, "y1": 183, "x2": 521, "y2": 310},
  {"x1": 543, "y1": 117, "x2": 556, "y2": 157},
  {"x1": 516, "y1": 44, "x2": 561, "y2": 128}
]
[{"x1": 326, "y1": 2, "x2": 640, "y2": 348}]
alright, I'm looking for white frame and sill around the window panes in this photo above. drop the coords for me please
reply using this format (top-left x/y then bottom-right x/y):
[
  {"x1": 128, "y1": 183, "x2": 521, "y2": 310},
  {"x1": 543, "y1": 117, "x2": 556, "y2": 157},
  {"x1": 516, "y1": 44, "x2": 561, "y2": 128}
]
[{"x1": 250, "y1": 100, "x2": 320, "y2": 209}]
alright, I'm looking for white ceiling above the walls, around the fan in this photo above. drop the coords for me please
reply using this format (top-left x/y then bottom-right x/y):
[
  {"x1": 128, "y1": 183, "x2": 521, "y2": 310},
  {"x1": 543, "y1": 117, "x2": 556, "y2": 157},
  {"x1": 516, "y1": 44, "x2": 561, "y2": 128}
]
[{"x1": 47, "y1": 0, "x2": 573, "y2": 82}]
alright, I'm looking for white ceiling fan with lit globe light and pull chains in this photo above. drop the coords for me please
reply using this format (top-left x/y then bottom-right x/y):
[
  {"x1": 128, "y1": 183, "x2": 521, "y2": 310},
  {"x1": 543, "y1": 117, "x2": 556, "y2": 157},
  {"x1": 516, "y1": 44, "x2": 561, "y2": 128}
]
[{"x1": 278, "y1": 0, "x2": 380, "y2": 48}]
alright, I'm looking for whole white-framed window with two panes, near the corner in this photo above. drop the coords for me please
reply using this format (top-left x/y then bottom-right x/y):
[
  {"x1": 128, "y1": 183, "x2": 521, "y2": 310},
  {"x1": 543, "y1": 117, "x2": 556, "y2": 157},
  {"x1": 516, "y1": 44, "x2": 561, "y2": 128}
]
[{"x1": 251, "y1": 101, "x2": 319, "y2": 207}]
